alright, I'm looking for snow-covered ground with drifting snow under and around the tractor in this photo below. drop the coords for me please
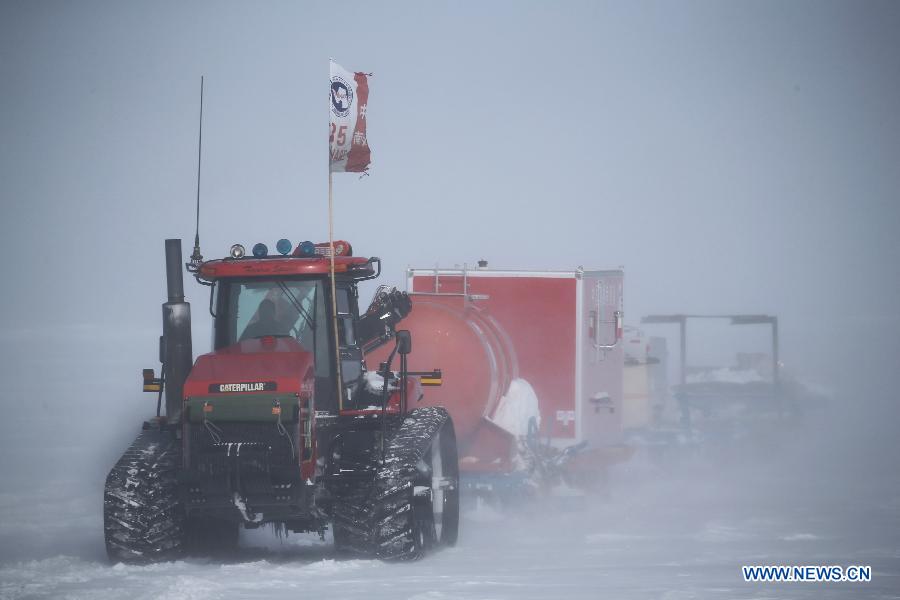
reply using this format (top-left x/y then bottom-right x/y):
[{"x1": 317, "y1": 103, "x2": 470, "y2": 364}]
[{"x1": 0, "y1": 336, "x2": 900, "y2": 600}]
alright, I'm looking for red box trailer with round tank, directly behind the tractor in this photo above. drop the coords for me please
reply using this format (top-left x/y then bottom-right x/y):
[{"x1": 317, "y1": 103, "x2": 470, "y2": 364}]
[{"x1": 366, "y1": 266, "x2": 628, "y2": 485}]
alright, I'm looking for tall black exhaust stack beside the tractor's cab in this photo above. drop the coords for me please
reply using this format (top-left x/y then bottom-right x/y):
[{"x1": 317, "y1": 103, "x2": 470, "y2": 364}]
[{"x1": 161, "y1": 240, "x2": 194, "y2": 423}]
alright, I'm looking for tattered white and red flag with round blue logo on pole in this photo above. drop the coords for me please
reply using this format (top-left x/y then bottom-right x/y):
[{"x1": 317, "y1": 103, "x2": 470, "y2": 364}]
[{"x1": 329, "y1": 61, "x2": 372, "y2": 173}]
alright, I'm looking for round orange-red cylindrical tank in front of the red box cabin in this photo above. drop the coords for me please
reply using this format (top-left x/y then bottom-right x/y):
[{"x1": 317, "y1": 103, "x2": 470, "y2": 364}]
[{"x1": 366, "y1": 294, "x2": 518, "y2": 442}]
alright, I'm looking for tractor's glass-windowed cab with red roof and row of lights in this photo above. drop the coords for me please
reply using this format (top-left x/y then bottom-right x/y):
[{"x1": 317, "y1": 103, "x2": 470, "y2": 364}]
[{"x1": 192, "y1": 240, "x2": 380, "y2": 414}]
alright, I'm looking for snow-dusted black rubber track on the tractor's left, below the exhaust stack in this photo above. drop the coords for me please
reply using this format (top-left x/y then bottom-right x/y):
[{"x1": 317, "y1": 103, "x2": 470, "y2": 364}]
[{"x1": 103, "y1": 430, "x2": 184, "y2": 563}]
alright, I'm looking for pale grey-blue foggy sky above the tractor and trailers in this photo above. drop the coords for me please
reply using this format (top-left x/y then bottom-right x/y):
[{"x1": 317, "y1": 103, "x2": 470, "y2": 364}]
[{"x1": 0, "y1": 1, "x2": 900, "y2": 390}]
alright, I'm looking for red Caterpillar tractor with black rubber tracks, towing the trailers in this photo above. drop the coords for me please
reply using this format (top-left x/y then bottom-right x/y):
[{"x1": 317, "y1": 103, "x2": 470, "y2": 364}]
[{"x1": 104, "y1": 240, "x2": 459, "y2": 563}]
